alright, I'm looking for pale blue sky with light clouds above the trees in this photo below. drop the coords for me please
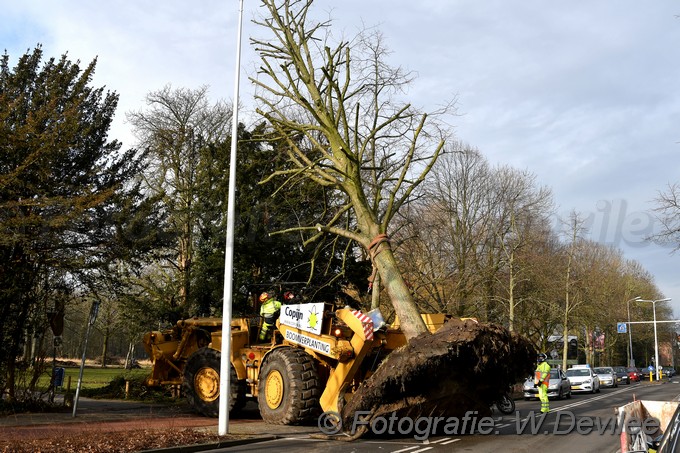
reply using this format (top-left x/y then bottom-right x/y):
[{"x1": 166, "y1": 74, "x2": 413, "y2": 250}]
[{"x1": 0, "y1": 0, "x2": 680, "y2": 321}]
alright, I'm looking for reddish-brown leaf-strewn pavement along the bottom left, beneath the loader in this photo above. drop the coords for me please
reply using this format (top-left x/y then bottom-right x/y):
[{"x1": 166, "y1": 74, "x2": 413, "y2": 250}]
[{"x1": 0, "y1": 397, "x2": 319, "y2": 453}]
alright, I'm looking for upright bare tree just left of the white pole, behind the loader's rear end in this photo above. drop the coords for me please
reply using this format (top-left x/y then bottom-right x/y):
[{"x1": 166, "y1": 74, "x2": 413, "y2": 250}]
[{"x1": 127, "y1": 86, "x2": 231, "y2": 316}]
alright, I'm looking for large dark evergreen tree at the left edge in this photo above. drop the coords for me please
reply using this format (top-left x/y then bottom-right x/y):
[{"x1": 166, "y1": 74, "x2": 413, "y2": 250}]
[{"x1": 0, "y1": 46, "x2": 153, "y2": 398}]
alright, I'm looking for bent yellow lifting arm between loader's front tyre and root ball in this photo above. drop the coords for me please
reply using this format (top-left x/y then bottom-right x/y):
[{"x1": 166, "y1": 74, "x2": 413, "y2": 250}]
[{"x1": 319, "y1": 308, "x2": 373, "y2": 413}]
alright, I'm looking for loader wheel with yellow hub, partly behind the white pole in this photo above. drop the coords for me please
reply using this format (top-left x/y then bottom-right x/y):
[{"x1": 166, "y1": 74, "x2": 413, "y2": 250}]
[{"x1": 183, "y1": 348, "x2": 245, "y2": 417}]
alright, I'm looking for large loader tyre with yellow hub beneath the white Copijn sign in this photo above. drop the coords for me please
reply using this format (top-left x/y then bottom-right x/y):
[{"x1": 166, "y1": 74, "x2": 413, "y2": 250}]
[{"x1": 257, "y1": 347, "x2": 321, "y2": 425}]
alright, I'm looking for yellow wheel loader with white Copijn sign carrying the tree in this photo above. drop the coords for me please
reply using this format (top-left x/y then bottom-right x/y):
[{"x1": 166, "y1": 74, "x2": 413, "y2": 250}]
[{"x1": 144, "y1": 303, "x2": 447, "y2": 424}]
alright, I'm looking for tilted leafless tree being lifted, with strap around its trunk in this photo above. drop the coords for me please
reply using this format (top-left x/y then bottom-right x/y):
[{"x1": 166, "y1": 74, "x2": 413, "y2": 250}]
[{"x1": 251, "y1": 0, "x2": 453, "y2": 339}]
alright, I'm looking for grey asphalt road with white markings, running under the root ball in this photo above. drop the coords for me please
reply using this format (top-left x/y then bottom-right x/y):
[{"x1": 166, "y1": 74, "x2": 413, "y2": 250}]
[{"x1": 207, "y1": 379, "x2": 680, "y2": 453}]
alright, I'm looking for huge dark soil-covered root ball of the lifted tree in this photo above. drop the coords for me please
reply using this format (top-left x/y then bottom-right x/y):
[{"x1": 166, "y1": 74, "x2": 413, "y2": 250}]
[{"x1": 341, "y1": 318, "x2": 536, "y2": 438}]
